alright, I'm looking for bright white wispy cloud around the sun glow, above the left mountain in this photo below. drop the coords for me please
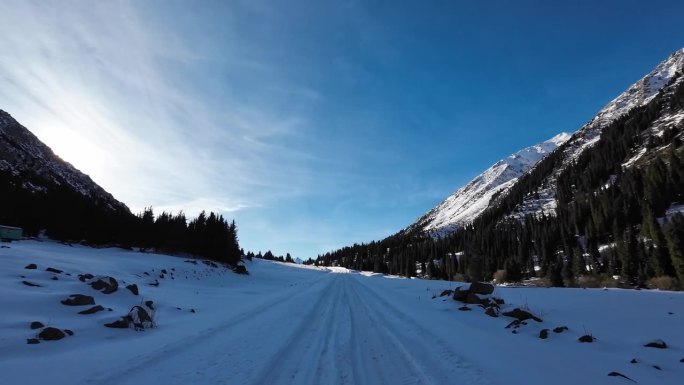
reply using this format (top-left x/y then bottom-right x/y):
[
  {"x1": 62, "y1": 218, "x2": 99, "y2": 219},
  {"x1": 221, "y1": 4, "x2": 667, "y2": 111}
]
[{"x1": 0, "y1": 0, "x2": 320, "y2": 219}]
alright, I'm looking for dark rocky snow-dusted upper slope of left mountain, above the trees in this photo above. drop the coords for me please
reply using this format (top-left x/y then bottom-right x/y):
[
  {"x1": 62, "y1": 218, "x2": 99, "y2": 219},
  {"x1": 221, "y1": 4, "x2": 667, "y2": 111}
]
[{"x1": 0, "y1": 110, "x2": 129, "y2": 211}]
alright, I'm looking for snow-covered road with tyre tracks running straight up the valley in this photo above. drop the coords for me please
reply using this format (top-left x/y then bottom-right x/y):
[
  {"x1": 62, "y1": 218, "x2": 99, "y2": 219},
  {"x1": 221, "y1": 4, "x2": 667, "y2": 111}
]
[{"x1": 89, "y1": 274, "x2": 489, "y2": 384}]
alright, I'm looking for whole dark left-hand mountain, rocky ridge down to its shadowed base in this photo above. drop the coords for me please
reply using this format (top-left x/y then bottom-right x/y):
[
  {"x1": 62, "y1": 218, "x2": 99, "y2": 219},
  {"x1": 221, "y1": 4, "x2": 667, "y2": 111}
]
[{"x1": 0, "y1": 110, "x2": 135, "y2": 243}]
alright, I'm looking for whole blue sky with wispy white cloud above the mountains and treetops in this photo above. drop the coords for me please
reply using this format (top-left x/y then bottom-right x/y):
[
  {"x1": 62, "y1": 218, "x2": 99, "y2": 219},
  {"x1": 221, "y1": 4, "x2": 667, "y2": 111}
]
[{"x1": 0, "y1": 0, "x2": 684, "y2": 258}]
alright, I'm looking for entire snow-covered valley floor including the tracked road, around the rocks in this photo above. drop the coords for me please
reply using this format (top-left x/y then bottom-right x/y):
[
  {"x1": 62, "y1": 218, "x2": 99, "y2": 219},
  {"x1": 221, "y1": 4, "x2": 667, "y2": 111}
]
[{"x1": 0, "y1": 241, "x2": 684, "y2": 384}]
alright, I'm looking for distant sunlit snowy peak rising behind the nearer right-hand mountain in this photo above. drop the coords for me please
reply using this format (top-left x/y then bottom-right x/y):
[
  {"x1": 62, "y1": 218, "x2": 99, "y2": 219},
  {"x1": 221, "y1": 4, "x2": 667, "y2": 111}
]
[{"x1": 409, "y1": 133, "x2": 571, "y2": 236}]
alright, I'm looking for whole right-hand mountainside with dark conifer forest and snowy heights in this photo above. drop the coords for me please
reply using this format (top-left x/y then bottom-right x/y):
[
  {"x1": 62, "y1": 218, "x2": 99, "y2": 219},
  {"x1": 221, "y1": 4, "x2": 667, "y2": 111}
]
[{"x1": 316, "y1": 49, "x2": 684, "y2": 288}]
